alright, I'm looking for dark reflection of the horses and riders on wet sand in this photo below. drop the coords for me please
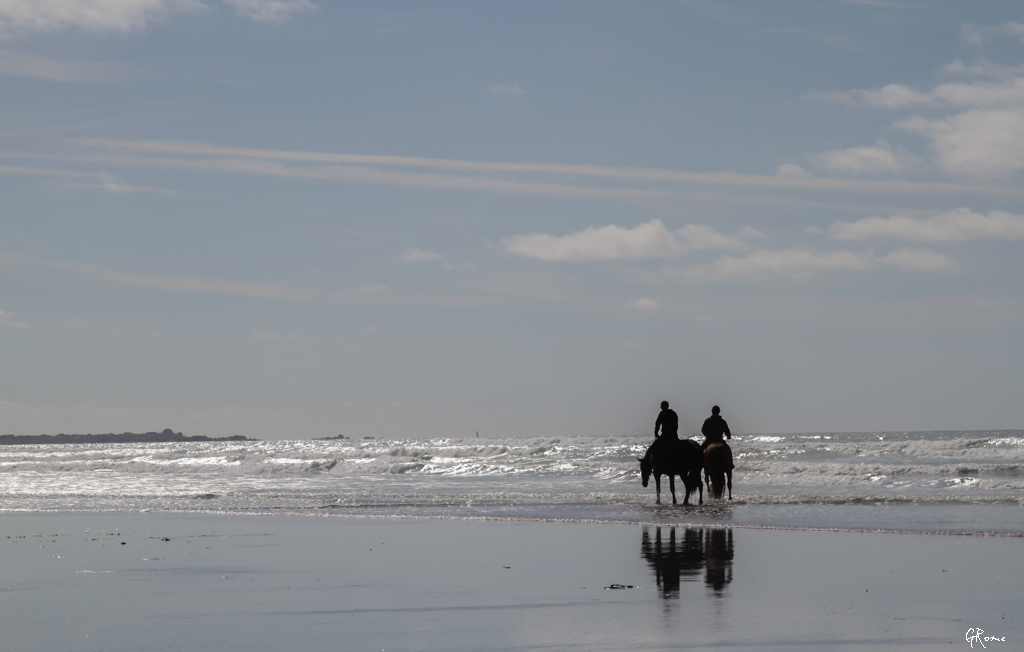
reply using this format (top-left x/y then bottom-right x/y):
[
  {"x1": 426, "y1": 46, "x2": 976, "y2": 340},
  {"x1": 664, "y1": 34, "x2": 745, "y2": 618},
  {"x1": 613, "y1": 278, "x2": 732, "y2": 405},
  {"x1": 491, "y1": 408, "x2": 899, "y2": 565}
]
[{"x1": 640, "y1": 526, "x2": 734, "y2": 599}]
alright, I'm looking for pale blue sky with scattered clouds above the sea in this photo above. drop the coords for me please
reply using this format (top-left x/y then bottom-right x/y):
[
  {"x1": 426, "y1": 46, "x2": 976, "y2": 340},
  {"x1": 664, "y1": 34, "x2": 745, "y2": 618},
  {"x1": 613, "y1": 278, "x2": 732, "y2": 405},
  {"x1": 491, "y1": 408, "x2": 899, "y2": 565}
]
[{"x1": 0, "y1": 0, "x2": 1024, "y2": 439}]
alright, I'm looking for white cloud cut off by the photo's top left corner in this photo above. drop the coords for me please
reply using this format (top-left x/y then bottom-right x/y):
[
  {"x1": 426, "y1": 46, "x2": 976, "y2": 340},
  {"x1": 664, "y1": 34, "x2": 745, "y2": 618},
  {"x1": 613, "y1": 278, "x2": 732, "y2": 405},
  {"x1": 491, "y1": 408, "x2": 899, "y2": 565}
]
[{"x1": 0, "y1": 0, "x2": 206, "y2": 34}]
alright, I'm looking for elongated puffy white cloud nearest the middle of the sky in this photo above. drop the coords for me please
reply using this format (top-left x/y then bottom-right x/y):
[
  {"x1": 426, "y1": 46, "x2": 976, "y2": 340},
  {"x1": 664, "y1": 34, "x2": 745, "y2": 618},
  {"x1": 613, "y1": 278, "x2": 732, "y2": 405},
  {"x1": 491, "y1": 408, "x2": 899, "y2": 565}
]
[{"x1": 502, "y1": 219, "x2": 680, "y2": 262}]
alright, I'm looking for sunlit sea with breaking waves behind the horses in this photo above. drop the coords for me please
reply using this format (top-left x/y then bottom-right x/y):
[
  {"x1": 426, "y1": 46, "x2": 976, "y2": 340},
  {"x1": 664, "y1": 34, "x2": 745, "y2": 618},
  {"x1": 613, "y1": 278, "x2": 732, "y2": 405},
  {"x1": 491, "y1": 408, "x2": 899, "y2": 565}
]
[{"x1": 0, "y1": 431, "x2": 1024, "y2": 535}]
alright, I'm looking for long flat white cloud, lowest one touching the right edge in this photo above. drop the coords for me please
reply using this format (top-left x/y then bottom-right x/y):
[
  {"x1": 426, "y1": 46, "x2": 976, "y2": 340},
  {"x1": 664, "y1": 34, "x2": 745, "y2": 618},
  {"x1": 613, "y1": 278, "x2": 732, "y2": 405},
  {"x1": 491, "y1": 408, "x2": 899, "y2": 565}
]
[{"x1": 828, "y1": 208, "x2": 1024, "y2": 243}]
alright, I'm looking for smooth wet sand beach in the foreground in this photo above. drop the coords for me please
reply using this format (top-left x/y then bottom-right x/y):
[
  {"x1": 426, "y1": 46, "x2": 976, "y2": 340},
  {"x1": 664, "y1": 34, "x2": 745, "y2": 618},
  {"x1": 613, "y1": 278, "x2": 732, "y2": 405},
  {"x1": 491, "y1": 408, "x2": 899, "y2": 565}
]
[{"x1": 0, "y1": 513, "x2": 1024, "y2": 652}]
